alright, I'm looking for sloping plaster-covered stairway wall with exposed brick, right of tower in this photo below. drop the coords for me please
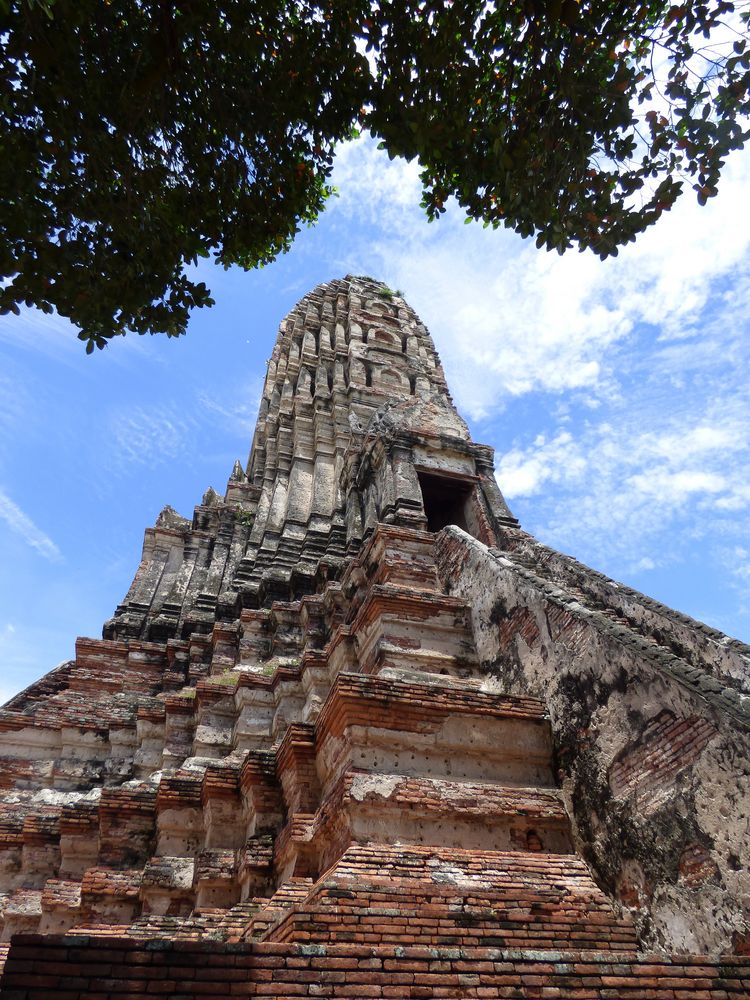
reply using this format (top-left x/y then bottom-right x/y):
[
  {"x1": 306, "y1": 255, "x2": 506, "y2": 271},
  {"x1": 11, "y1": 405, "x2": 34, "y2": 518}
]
[{"x1": 437, "y1": 527, "x2": 750, "y2": 954}]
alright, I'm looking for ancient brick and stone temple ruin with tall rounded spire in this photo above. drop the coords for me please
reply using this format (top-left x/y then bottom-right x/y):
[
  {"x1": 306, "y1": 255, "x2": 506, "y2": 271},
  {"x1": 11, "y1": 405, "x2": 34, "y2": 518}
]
[{"x1": 0, "y1": 277, "x2": 750, "y2": 1000}]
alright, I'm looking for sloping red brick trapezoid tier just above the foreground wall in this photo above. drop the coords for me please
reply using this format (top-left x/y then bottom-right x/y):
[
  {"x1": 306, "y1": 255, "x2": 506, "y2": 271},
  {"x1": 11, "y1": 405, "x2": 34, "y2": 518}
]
[{"x1": 268, "y1": 845, "x2": 637, "y2": 951}]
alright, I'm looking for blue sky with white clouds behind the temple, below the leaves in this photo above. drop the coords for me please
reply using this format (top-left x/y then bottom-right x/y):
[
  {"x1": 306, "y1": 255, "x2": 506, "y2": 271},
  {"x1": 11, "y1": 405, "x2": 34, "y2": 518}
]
[{"x1": 0, "y1": 140, "x2": 750, "y2": 700}]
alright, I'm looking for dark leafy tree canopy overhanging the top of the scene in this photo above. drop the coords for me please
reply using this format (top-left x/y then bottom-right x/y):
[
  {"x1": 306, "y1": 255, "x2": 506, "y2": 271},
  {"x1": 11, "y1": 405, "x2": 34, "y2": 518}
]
[{"x1": 0, "y1": 0, "x2": 750, "y2": 350}]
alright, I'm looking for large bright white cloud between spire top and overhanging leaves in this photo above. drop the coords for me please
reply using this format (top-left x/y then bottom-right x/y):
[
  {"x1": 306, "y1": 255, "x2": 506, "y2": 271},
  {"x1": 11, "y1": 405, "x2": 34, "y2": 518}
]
[{"x1": 333, "y1": 132, "x2": 750, "y2": 418}]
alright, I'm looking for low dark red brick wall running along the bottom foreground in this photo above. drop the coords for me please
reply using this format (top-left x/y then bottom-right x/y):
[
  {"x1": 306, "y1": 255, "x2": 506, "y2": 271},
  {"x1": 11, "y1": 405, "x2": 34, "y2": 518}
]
[{"x1": 0, "y1": 935, "x2": 750, "y2": 1000}]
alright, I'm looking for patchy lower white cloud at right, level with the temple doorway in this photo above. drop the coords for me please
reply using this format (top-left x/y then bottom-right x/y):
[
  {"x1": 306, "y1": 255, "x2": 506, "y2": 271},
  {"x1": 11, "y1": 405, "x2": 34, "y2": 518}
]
[{"x1": 497, "y1": 397, "x2": 750, "y2": 570}]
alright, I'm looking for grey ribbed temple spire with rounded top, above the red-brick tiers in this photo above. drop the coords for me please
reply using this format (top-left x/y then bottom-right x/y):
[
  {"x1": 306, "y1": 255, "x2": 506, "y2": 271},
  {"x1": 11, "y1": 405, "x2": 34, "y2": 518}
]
[{"x1": 104, "y1": 275, "x2": 510, "y2": 638}]
